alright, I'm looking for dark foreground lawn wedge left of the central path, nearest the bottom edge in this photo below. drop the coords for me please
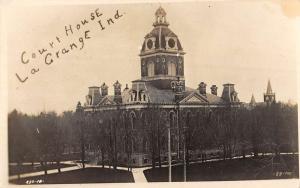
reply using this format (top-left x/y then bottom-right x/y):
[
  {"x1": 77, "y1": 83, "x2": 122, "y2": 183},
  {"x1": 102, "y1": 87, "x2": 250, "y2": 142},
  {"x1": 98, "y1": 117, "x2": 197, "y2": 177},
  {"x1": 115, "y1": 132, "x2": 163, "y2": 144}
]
[{"x1": 10, "y1": 168, "x2": 134, "y2": 184}]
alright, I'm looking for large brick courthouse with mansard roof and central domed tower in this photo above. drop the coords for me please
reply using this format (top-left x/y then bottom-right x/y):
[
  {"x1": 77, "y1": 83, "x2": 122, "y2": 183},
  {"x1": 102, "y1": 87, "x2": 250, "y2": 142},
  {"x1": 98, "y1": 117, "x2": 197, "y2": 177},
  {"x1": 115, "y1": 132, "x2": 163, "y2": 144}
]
[{"x1": 77, "y1": 7, "x2": 240, "y2": 166}]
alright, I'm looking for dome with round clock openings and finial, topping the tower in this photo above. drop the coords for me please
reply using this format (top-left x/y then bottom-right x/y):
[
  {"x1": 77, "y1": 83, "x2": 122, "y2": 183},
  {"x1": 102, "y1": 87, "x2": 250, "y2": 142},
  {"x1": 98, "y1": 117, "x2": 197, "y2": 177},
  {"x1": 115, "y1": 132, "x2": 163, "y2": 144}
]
[{"x1": 141, "y1": 7, "x2": 183, "y2": 55}]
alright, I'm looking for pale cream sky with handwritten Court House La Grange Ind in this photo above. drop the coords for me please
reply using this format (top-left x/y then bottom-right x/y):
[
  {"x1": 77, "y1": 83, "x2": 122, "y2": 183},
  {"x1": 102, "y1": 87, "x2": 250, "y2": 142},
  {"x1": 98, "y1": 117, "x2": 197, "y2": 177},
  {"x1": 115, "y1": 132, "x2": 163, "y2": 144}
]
[{"x1": 5, "y1": 1, "x2": 300, "y2": 114}]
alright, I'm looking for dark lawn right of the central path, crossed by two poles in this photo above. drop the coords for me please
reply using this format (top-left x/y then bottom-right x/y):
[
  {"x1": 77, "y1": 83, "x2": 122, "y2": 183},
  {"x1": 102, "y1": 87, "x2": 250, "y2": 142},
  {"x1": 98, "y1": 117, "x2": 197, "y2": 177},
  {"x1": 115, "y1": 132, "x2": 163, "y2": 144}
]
[{"x1": 144, "y1": 155, "x2": 299, "y2": 182}]
